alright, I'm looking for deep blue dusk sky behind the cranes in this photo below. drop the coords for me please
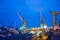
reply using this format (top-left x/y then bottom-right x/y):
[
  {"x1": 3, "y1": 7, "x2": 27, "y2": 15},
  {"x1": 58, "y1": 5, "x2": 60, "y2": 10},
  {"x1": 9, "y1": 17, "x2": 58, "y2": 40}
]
[{"x1": 0, "y1": 0, "x2": 60, "y2": 28}]
